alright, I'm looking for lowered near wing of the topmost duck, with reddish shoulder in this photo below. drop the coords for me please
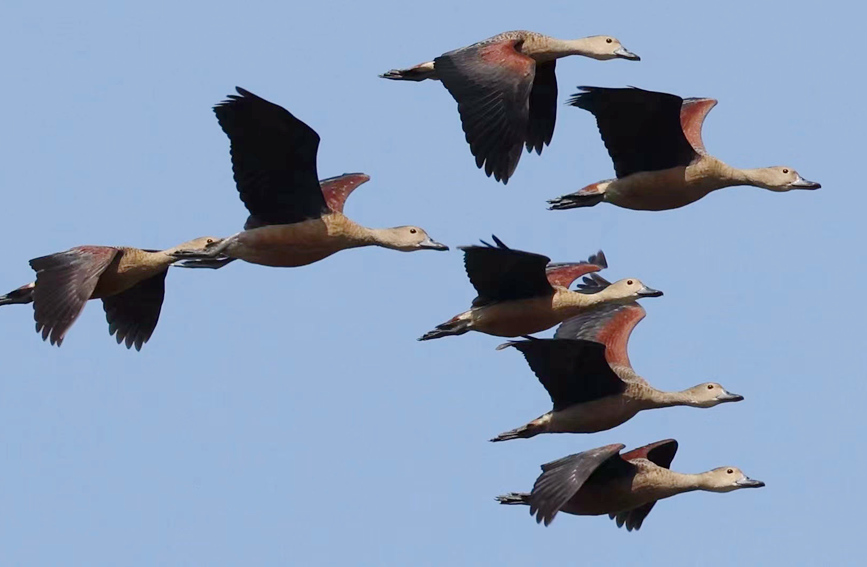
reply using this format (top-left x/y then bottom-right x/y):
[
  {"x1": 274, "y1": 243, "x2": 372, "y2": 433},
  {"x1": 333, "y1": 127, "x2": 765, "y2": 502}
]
[{"x1": 434, "y1": 39, "x2": 536, "y2": 183}]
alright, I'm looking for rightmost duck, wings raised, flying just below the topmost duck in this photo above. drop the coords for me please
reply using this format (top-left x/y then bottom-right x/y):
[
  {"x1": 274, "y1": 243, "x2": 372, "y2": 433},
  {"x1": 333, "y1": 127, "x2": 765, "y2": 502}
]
[{"x1": 549, "y1": 87, "x2": 821, "y2": 211}]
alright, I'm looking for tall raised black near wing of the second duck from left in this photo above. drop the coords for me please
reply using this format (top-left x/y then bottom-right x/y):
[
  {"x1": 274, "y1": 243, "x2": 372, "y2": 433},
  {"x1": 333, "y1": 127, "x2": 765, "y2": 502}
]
[{"x1": 214, "y1": 87, "x2": 329, "y2": 226}]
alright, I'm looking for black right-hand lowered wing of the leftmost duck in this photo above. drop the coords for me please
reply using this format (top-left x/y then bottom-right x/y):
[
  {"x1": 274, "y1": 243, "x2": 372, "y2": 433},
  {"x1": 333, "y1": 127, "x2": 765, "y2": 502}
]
[{"x1": 102, "y1": 270, "x2": 169, "y2": 350}]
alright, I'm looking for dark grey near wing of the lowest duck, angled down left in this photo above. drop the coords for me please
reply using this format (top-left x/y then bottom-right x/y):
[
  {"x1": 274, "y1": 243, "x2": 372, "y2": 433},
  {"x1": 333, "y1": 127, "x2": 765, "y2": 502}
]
[{"x1": 530, "y1": 443, "x2": 632, "y2": 526}]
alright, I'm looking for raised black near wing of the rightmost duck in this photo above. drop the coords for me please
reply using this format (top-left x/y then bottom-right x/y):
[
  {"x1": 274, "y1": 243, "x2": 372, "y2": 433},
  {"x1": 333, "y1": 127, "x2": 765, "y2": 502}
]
[{"x1": 569, "y1": 87, "x2": 698, "y2": 177}]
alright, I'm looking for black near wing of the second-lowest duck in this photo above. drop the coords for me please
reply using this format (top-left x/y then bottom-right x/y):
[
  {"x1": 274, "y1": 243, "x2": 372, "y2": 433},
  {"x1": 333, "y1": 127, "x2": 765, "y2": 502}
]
[{"x1": 506, "y1": 339, "x2": 626, "y2": 411}]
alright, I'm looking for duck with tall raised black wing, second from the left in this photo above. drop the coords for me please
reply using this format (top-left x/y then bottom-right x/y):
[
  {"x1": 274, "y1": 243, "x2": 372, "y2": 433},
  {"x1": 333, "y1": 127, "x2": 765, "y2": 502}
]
[{"x1": 175, "y1": 88, "x2": 448, "y2": 268}]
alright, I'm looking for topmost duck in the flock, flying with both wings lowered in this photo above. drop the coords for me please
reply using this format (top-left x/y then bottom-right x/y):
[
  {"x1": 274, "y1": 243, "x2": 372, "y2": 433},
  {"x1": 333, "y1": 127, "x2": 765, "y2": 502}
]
[{"x1": 380, "y1": 31, "x2": 639, "y2": 184}]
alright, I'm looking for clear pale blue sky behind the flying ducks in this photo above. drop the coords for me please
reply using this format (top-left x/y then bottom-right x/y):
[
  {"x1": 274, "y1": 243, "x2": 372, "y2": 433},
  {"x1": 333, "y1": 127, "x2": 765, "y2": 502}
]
[{"x1": 0, "y1": 0, "x2": 867, "y2": 567}]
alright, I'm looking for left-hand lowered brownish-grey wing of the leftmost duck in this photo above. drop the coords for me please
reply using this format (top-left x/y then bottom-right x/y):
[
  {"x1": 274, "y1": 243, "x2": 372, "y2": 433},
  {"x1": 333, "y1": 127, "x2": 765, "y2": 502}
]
[{"x1": 30, "y1": 246, "x2": 119, "y2": 346}]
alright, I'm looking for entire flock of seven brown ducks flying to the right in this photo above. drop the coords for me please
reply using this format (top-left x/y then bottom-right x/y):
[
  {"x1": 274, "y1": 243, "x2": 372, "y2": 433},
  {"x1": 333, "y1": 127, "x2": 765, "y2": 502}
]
[{"x1": 0, "y1": 31, "x2": 820, "y2": 531}]
